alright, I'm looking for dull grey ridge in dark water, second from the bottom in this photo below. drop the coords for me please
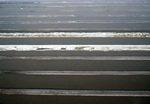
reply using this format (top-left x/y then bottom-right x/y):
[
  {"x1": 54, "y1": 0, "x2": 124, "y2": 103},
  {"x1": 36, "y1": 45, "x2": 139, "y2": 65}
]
[{"x1": 0, "y1": 71, "x2": 150, "y2": 76}]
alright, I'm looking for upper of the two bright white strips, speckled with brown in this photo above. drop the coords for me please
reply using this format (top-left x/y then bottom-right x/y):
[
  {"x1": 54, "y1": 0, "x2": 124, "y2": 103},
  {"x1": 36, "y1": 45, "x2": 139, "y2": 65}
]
[{"x1": 0, "y1": 32, "x2": 150, "y2": 38}]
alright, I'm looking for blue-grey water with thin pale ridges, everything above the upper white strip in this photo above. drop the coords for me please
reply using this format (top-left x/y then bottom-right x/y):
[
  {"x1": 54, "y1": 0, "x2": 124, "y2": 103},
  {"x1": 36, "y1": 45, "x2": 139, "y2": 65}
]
[{"x1": 0, "y1": 0, "x2": 150, "y2": 32}]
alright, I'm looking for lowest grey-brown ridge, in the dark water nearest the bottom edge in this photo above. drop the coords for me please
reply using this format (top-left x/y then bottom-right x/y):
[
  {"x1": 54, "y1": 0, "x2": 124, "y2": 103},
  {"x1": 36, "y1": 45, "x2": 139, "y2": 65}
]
[{"x1": 0, "y1": 89, "x2": 150, "y2": 97}]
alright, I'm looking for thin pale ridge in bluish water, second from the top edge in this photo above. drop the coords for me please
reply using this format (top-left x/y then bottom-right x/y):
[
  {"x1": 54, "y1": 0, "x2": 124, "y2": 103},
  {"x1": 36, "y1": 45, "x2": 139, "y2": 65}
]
[{"x1": 0, "y1": 5, "x2": 150, "y2": 8}]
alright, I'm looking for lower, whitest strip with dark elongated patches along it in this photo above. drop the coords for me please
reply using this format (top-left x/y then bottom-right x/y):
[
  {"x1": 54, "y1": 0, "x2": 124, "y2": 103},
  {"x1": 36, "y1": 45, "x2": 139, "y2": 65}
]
[{"x1": 0, "y1": 45, "x2": 150, "y2": 51}]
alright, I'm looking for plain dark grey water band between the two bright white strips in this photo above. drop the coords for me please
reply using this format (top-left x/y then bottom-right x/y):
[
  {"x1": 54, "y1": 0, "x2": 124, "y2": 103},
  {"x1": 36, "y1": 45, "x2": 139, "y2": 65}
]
[{"x1": 0, "y1": 38, "x2": 150, "y2": 45}]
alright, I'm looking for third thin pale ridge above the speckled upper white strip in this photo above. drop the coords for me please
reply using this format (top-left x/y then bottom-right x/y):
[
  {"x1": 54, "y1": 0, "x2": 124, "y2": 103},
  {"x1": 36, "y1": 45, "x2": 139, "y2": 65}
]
[{"x1": 0, "y1": 15, "x2": 150, "y2": 17}]
